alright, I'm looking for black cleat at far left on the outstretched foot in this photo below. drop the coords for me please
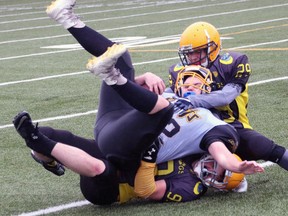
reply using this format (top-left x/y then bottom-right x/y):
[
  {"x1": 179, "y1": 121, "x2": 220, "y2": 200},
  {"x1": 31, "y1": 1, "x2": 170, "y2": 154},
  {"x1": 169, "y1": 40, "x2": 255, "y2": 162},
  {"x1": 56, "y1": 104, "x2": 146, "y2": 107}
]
[{"x1": 13, "y1": 111, "x2": 38, "y2": 141}]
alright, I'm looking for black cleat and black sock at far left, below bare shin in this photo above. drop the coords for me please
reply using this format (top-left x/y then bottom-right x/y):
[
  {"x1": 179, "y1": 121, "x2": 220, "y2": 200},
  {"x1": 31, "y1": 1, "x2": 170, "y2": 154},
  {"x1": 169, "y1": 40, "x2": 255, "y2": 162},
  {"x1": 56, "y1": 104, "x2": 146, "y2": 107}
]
[{"x1": 13, "y1": 111, "x2": 56, "y2": 156}]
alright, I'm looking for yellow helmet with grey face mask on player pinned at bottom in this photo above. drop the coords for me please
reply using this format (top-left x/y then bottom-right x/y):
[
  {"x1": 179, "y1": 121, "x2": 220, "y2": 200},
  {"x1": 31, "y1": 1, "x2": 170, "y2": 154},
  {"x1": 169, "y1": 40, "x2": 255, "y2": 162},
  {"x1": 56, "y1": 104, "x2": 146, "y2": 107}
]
[{"x1": 193, "y1": 154, "x2": 245, "y2": 191}]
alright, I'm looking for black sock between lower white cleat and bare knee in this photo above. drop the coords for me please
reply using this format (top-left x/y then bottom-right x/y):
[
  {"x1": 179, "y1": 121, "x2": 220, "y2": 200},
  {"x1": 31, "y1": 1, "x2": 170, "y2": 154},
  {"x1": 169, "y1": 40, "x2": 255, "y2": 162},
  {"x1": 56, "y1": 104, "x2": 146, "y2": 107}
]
[{"x1": 111, "y1": 80, "x2": 158, "y2": 113}]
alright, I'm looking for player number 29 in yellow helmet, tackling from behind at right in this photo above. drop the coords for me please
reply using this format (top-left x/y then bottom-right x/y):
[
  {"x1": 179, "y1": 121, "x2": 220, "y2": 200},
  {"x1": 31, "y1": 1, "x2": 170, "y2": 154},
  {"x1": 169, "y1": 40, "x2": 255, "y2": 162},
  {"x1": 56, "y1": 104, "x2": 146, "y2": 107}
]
[{"x1": 169, "y1": 22, "x2": 288, "y2": 170}]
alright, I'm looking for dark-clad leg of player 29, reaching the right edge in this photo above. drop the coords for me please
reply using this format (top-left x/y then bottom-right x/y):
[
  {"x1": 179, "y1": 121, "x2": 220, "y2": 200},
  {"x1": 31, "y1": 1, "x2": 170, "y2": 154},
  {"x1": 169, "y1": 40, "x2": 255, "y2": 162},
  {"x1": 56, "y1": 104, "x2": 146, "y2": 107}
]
[{"x1": 236, "y1": 129, "x2": 288, "y2": 170}]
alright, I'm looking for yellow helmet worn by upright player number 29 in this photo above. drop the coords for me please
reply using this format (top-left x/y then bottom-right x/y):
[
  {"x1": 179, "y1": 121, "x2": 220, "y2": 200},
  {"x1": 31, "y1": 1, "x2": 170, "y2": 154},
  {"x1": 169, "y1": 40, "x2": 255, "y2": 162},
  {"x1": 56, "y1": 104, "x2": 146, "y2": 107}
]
[{"x1": 178, "y1": 22, "x2": 221, "y2": 67}]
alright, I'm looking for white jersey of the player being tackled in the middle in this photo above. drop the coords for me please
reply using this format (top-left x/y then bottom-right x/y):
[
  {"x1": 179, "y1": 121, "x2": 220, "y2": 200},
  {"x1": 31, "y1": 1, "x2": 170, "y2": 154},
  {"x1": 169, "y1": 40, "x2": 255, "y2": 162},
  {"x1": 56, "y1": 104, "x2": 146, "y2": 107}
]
[{"x1": 156, "y1": 93, "x2": 227, "y2": 164}]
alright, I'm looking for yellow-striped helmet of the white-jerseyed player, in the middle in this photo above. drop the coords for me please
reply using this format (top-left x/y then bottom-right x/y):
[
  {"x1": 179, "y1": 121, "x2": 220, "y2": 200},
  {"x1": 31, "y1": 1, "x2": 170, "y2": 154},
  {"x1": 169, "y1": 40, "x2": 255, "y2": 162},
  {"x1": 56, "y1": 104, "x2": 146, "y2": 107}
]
[{"x1": 174, "y1": 65, "x2": 213, "y2": 97}]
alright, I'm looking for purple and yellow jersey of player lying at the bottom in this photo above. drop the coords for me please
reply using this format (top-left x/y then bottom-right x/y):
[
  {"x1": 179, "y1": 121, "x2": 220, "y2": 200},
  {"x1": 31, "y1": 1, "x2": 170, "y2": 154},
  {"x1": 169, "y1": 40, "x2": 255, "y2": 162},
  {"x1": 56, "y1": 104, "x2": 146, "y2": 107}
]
[{"x1": 118, "y1": 157, "x2": 207, "y2": 203}]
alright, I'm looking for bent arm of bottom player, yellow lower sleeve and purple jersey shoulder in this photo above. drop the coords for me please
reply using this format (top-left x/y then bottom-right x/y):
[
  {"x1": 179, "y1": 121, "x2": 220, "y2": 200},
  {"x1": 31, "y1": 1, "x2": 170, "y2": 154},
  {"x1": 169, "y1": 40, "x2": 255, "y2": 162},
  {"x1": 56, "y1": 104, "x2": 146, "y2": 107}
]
[{"x1": 134, "y1": 160, "x2": 207, "y2": 202}]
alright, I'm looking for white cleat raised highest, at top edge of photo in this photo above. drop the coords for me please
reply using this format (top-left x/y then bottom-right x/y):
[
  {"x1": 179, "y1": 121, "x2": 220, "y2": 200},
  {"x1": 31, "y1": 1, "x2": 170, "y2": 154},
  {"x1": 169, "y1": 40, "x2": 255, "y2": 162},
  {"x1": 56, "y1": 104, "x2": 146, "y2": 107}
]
[{"x1": 46, "y1": 0, "x2": 85, "y2": 29}]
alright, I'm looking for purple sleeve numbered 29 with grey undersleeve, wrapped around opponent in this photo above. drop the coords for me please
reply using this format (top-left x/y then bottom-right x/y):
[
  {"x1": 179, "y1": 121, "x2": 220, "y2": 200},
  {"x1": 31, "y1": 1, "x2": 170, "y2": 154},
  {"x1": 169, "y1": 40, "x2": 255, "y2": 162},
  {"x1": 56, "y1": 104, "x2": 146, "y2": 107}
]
[{"x1": 184, "y1": 52, "x2": 251, "y2": 109}]
